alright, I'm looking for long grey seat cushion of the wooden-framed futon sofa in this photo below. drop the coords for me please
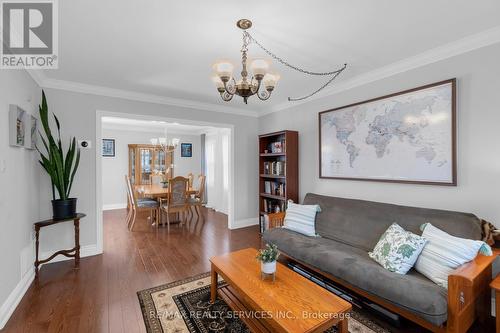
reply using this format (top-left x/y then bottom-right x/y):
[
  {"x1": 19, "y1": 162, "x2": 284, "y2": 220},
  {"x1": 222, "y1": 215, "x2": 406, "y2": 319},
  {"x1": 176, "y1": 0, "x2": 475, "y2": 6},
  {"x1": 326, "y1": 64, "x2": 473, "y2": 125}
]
[{"x1": 263, "y1": 228, "x2": 447, "y2": 325}]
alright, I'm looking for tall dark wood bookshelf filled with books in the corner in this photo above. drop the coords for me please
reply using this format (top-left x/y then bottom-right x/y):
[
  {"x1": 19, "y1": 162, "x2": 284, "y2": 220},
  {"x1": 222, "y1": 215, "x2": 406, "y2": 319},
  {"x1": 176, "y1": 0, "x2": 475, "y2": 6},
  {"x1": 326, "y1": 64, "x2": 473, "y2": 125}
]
[{"x1": 259, "y1": 130, "x2": 299, "y2": 230}]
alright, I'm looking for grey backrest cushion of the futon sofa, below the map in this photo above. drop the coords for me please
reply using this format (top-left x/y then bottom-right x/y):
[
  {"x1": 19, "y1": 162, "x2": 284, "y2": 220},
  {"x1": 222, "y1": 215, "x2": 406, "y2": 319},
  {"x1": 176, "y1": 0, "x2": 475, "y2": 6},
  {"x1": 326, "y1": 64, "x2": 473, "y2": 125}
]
[{"x1": 304, "y1": 193, "x2": 481, "y2": 251}]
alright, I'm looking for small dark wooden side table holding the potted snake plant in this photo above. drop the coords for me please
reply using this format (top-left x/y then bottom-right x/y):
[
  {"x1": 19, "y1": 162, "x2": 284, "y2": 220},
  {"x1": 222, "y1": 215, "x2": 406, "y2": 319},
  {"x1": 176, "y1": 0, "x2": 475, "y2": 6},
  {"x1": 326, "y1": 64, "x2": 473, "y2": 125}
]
[{"x1": 35, "y1": 213, "x2": 86, "y2": 278}]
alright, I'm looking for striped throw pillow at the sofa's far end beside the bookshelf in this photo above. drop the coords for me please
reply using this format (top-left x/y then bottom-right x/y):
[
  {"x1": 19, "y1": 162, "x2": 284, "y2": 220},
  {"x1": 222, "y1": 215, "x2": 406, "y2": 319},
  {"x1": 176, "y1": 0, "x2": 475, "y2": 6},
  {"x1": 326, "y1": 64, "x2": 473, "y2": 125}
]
[{"x1": 283, "y1": 201, "x2": 321, "y2": 236}]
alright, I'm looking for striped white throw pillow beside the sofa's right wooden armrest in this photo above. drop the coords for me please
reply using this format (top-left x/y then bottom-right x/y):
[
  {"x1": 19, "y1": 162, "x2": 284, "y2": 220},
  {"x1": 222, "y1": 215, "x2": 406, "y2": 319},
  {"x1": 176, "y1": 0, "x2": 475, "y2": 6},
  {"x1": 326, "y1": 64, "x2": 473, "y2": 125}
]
[{"x1": 415, "y1": 223, "x2": 492, "y2": 289}]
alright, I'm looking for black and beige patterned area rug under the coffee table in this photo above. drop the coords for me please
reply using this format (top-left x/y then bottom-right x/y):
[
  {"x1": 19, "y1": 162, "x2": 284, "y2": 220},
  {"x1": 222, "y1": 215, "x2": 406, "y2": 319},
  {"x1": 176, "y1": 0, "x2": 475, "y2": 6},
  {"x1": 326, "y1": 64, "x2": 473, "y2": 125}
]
[{"x1": 137, "y1": 273, "x2": 389, "y2": 333}]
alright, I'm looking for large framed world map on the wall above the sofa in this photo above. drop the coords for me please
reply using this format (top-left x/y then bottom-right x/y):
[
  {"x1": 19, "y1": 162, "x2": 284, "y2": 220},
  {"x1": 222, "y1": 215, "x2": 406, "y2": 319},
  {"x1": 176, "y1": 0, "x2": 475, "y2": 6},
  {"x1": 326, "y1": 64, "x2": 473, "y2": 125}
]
[{"x1": 319, "y1": 79, "x2": 457, "y2": 186}]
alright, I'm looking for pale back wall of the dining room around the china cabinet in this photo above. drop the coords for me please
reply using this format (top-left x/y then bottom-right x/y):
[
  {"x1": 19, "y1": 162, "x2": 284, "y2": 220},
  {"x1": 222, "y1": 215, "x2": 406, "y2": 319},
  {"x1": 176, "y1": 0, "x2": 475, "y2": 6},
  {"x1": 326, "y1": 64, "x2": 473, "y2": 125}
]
[{"x1": 102, "y1": 128, "x2": 201, "y2": 209}]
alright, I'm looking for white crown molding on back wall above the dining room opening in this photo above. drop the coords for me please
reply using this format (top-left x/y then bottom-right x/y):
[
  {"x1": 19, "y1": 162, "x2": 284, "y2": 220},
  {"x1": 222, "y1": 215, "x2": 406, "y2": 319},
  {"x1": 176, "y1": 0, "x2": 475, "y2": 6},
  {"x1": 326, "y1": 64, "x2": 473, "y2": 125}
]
[{"x1": 39, "y1": 78, "x2": 258, "y2": 117}]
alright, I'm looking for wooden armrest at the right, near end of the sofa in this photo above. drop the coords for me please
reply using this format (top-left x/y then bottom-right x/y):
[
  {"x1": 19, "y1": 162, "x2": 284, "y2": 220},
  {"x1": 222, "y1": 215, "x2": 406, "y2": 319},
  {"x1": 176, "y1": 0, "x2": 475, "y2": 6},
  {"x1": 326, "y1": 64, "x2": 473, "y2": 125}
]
[{"x1": 446, "y1": 250, "x2": 500, "y2": 333}]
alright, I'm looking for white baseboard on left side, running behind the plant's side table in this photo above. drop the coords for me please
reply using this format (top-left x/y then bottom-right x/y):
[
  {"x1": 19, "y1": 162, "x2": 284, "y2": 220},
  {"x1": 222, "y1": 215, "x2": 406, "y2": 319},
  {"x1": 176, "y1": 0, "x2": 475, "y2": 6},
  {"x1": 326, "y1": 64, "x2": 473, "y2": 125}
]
[{"x1": 0, "y1": 244, "x2": 102, "y2": 330}]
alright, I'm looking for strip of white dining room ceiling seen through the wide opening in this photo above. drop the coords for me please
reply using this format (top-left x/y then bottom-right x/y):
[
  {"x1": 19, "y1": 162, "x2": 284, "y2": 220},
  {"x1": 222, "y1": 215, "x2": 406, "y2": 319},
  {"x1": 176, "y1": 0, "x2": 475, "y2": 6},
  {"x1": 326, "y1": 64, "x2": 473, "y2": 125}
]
[{"x1": 102, "y1": 117, "x2": 215, "y2": 135}]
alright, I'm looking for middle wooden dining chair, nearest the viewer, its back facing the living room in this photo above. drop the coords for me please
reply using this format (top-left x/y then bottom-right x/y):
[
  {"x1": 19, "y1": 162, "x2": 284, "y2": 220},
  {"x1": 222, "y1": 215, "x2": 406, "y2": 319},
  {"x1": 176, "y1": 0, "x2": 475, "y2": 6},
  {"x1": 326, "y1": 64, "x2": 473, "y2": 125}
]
[{"x1": 160, "y1": 176, "x2": 189, "y2": 231}]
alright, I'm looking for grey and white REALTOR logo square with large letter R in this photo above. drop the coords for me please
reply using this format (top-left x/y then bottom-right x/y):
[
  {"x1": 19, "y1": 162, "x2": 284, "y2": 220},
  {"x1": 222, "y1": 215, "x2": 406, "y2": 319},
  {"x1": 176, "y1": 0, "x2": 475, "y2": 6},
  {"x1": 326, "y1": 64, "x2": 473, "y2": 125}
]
[{"x1": 0, "y1": 0, "x2": 58, "y2": 69}]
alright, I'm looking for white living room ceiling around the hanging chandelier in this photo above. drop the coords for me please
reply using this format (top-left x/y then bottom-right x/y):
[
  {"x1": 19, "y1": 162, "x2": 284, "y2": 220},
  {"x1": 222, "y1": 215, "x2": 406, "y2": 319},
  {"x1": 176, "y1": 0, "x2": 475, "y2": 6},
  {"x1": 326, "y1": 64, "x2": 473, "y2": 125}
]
[{"x1": 38, "y1": 0, "x2": 500, "y2": 112}]
